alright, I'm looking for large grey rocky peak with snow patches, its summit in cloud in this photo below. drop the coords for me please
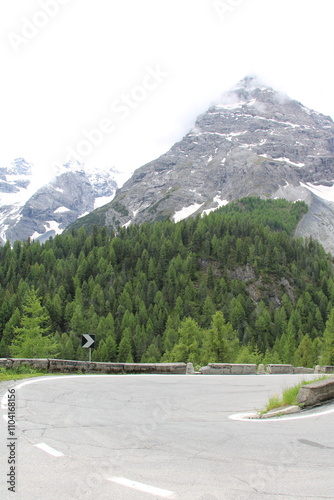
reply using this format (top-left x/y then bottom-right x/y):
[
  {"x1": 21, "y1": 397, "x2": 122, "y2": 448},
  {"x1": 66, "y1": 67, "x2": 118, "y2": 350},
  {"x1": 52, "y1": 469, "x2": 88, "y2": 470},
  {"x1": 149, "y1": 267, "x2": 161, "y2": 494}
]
[{"x1": 74, "y1": 77, "x2": 334, "y2": 252}]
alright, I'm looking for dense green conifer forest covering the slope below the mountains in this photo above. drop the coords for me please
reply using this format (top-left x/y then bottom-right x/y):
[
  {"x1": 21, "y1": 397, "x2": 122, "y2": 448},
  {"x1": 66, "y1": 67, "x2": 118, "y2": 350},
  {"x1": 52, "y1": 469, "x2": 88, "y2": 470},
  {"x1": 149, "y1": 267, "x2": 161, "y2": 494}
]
[{"x1": 0, "y1": 198, "x2": 334, "y2": 367}]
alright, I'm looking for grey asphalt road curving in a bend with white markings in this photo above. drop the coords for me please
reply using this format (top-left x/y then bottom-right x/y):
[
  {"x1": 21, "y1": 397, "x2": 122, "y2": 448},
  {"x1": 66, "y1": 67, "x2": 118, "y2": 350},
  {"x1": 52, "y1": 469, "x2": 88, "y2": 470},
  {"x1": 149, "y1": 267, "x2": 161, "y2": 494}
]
[{"x1": 0, "y1": 375, "x2": 334, "y2": 500}]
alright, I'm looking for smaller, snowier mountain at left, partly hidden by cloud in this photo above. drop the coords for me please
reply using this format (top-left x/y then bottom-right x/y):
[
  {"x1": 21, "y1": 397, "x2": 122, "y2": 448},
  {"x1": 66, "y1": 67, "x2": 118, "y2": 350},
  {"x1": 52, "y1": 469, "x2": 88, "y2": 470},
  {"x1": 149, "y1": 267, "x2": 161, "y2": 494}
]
[{"x1": 0, "y1": 158, "x2": 117, "y2": 244}]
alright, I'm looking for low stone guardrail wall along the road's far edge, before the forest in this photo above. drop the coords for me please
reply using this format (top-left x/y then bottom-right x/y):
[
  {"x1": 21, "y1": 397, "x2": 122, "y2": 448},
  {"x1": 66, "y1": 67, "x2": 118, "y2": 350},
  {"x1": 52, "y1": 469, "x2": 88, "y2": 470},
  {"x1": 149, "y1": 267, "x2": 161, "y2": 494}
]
[{"x1": 0, "y1": 358, "x2": 334, "y2": 375}]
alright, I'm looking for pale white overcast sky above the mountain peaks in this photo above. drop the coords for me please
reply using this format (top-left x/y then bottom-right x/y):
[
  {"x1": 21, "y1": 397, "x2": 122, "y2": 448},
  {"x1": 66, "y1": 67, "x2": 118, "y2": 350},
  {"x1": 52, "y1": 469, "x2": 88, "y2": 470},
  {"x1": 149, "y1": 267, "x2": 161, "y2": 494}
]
[{"x1": 0, "y1": 0, "x2": 334, "y2": 186}]
